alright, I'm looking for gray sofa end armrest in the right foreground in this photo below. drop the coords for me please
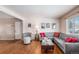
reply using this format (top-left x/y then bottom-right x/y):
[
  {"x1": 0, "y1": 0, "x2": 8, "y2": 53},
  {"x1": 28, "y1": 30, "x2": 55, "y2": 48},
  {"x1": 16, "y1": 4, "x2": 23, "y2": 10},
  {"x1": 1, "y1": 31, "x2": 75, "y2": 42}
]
[{"x1": 64, "y1": 42, "x2": 79, "y2": 54}]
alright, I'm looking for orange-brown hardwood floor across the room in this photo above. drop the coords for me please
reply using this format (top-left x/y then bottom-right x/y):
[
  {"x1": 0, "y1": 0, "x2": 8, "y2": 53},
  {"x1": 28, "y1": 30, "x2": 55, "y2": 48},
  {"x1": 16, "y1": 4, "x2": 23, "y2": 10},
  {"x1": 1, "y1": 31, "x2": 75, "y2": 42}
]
[{"x1": 0, "y1": 40, "x2": 62, "y2": 54}]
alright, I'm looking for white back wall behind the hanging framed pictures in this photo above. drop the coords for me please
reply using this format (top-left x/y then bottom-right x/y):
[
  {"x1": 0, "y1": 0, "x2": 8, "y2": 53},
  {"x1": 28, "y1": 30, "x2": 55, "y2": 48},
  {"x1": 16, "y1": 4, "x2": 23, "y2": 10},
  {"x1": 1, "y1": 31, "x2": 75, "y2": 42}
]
[{"x1": 23, "y1": 17, "x2": 59, "y2": 33}]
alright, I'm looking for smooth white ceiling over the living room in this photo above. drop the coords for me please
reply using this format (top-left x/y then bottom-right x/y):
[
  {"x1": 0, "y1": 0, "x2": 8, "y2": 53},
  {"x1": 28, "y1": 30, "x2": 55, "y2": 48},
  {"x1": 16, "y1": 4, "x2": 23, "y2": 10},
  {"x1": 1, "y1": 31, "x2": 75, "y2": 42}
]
[{"x1": 4, "y1": 5, "x2": 76, "y2": 18}]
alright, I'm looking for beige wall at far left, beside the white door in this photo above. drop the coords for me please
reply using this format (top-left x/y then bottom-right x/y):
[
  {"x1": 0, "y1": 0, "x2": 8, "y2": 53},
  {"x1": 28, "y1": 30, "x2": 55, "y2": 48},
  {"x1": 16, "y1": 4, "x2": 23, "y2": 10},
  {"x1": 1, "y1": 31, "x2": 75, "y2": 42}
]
[{"x1": 0, "y1": 18, "x2": 15, "y2": 40}]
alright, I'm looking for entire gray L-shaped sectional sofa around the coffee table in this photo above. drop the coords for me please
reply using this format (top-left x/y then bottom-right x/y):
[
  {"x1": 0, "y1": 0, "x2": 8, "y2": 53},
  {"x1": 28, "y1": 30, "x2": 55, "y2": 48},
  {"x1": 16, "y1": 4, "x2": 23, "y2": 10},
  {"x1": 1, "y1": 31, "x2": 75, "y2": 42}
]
[{"x1": 39, "y1": 32, "x2": 79, "y2": 54}]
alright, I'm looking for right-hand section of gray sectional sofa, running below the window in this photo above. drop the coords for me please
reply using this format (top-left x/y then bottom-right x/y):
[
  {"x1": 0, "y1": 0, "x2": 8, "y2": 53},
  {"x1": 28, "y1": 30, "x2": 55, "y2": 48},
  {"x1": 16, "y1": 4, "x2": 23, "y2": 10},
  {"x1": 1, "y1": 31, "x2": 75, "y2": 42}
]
[{"x1": 54, "y1": 33, "x2": 79, "y2": 54}]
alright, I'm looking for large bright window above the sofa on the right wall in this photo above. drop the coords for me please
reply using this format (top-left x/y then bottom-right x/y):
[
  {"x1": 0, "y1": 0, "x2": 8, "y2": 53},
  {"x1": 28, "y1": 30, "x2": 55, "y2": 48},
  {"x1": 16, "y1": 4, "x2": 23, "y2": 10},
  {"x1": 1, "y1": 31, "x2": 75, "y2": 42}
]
[{"x1": 66, "y1": 16, "x2": 79, "y2": 34}]
